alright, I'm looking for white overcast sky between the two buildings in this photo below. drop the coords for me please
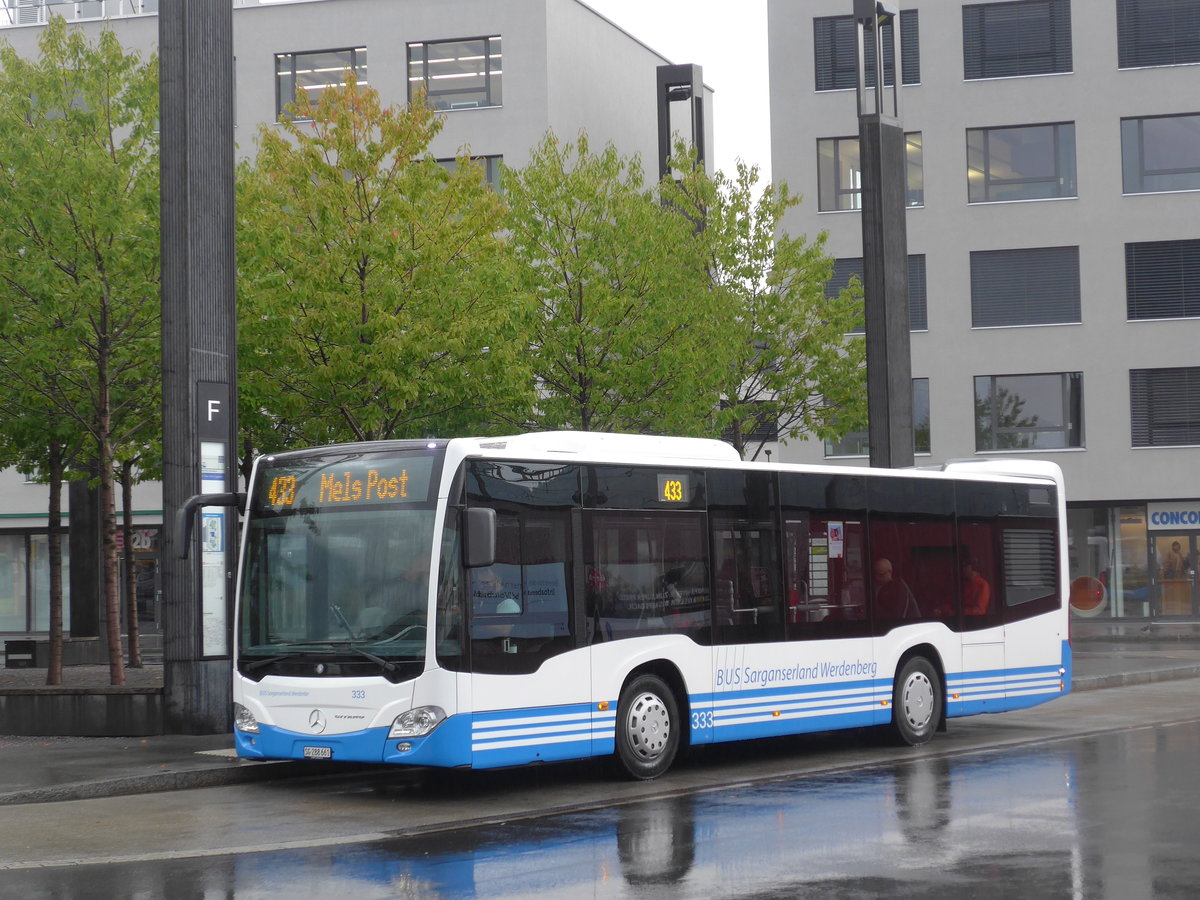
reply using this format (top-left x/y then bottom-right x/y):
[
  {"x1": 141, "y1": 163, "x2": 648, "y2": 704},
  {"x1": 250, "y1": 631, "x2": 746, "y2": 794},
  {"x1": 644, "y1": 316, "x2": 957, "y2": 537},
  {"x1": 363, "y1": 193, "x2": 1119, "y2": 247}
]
[{"x1": 583, "y1": 0, "x2": 770, "y2": 180}]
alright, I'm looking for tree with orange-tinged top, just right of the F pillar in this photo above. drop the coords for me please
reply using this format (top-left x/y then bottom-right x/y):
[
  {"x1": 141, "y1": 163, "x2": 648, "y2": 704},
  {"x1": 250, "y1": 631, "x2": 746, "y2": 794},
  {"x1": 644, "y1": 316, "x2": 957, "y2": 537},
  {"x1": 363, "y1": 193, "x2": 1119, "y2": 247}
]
[{"x1": 238, "y1": 76, "x2": 533, "y2": 465}]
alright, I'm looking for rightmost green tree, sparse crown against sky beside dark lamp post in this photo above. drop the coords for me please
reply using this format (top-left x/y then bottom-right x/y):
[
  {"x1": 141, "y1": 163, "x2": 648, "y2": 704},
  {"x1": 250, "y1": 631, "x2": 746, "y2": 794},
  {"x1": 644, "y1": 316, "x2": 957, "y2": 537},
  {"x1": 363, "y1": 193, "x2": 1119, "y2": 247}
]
[{"x1": 662, "y1": 153, "x2": 866, "y2": 458}]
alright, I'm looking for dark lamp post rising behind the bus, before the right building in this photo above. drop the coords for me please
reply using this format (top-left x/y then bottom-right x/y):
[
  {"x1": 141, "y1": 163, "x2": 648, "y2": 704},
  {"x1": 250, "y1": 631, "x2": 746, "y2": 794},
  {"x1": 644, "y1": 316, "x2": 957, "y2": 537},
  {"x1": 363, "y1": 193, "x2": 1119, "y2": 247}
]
[{"x1": 854, "y1": 0, "x2": 913, "y2": 468}]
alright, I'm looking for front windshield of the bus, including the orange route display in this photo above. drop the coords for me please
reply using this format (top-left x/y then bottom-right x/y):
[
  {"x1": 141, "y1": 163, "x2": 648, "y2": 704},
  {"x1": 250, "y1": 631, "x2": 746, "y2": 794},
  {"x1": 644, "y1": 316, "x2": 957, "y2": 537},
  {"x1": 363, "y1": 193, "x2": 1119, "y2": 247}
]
[{"x1": 239, "y1": 450, "x2": 438, "y2": 673}]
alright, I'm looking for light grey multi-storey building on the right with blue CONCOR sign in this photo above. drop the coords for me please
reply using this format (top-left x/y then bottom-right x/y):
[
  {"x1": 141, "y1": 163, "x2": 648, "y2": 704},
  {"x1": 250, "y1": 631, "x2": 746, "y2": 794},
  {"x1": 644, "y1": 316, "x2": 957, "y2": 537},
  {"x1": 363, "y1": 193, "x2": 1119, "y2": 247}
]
[{"x1": 768, "y1": 0, "x2": 1200, "y2": 622}]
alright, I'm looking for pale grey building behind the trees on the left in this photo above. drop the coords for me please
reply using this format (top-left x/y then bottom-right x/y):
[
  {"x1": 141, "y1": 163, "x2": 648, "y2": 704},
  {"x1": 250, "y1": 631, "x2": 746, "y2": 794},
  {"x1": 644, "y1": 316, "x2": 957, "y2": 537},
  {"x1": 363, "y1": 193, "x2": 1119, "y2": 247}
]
[{"x1": 0, "y1": 0, "x2": 712, "y2": 638}]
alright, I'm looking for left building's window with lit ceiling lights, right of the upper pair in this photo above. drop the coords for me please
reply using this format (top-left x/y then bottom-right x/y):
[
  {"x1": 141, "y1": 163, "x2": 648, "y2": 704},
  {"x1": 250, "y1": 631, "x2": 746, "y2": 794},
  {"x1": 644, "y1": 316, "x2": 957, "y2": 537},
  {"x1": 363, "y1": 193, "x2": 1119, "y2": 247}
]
[{"x1": 408, "y1": 36, "x2": 504, "y2": 109}]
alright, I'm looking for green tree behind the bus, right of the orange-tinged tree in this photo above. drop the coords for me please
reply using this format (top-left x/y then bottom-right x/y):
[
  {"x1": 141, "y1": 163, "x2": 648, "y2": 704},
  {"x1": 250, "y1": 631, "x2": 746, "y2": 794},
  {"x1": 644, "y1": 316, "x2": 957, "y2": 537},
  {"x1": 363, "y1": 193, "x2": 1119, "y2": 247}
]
[{"x1": 503, "y1": 133, "x2": 720, "y2": 434}]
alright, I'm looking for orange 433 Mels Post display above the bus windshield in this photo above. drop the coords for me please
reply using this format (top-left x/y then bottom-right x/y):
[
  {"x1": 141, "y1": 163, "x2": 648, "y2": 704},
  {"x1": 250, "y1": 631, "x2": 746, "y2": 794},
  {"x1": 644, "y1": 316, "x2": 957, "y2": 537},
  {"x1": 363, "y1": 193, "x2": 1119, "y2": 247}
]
[{"x1": 254, "y1": 454, "x2": 434, "y2": 511}]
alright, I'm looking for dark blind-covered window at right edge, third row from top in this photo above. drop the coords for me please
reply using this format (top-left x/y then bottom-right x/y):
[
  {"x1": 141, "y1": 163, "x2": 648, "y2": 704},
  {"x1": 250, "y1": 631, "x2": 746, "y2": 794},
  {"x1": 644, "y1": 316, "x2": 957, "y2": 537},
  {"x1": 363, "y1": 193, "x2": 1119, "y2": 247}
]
[{"x1": 1126, "y1": 240, "x2": 1200, "y2": 319}]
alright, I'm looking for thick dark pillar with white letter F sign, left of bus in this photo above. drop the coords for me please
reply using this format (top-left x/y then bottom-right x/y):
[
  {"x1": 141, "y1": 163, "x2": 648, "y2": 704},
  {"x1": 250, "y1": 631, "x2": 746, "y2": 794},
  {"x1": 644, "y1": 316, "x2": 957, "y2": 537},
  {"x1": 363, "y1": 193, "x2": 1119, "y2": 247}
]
[{"x1": 158, "y1": 0, "x2": 236, "y2": 734}]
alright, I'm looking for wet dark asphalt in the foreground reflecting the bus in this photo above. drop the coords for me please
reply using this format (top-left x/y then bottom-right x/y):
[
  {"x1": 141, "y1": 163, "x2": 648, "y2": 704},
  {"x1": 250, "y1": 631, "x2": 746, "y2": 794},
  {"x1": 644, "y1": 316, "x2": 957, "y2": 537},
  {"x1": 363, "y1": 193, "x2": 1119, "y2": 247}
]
[{"x1": 7, "y1": 719, "x2": 1200, "y2": 900}]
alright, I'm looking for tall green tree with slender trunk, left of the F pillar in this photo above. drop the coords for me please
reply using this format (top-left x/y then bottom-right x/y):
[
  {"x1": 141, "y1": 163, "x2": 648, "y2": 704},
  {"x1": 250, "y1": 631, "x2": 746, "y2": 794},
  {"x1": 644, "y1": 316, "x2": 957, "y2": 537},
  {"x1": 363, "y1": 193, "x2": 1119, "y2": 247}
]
[{"x1": 0, "y1": 18, "x2": 160, "y2": 684}]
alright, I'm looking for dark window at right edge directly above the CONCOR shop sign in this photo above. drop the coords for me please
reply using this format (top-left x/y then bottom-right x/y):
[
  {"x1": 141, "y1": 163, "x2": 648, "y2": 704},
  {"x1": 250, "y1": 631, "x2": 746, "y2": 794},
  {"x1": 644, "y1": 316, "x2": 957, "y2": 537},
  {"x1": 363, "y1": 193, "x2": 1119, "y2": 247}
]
[{"x1": 1129, "y1": 366, "x2": 1200, "y2": 446}]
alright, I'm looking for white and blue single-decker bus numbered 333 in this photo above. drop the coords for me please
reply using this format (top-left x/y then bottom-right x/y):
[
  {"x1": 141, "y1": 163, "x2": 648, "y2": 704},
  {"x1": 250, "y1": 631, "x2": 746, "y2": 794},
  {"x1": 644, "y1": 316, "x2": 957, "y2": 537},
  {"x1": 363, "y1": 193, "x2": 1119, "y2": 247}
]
[{"x1": 201, "y1": 432, "x2": 1070, "y2": 779}]
